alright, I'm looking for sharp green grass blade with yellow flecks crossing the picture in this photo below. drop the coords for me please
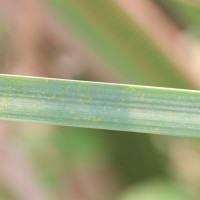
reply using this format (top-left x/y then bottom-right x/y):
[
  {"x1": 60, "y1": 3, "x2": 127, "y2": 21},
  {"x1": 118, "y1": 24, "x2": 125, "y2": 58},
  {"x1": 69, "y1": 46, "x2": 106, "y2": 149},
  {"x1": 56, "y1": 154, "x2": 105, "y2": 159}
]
[{"x1": 0, "y1": 75, "x2": 200, "y2": 136}]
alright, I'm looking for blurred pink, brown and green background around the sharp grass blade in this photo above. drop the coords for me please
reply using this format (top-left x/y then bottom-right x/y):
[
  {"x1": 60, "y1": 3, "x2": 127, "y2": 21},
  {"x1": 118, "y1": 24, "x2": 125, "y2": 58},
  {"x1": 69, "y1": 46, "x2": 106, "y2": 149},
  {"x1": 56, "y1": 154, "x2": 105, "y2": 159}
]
[{"x1": 0, "y1": 0, "x2": 200, "y2": 200}]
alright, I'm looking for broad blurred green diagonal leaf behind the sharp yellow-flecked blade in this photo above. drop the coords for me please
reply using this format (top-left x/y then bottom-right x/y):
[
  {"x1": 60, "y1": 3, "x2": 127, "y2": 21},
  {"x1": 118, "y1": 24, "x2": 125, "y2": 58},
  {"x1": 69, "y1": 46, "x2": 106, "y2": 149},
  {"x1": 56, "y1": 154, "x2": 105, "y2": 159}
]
[{"x1": 50, "y1": 0, "x2": 193, "y2": 89}]
